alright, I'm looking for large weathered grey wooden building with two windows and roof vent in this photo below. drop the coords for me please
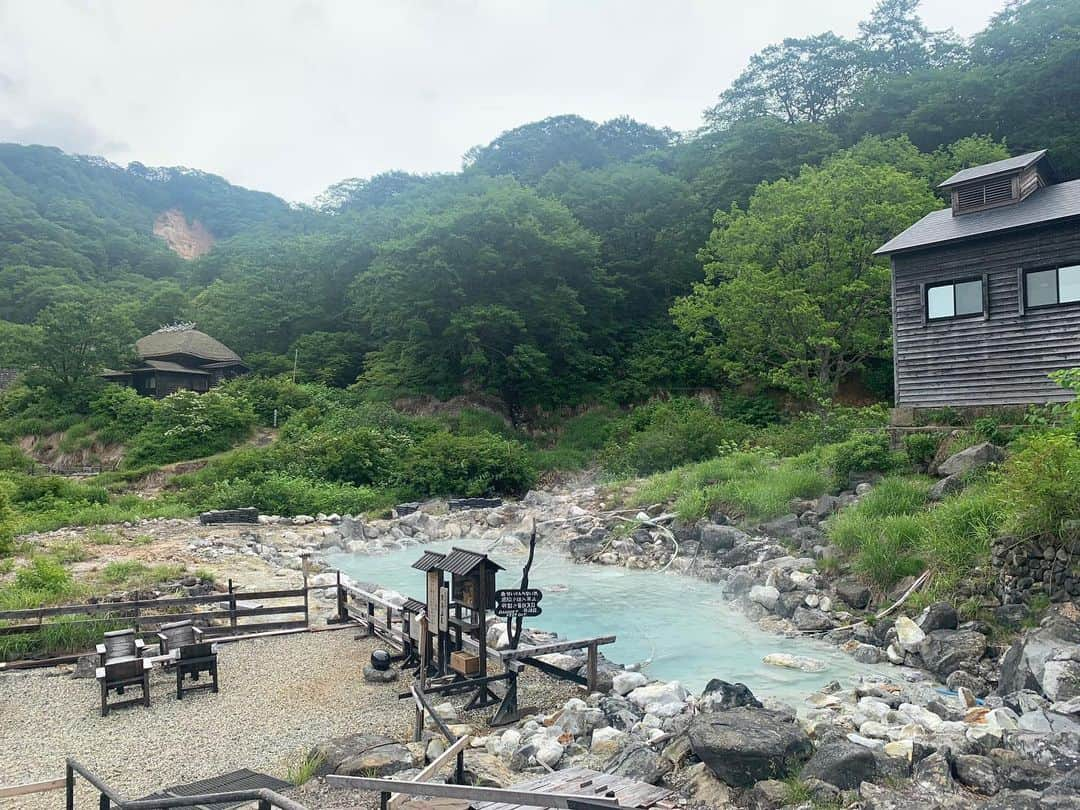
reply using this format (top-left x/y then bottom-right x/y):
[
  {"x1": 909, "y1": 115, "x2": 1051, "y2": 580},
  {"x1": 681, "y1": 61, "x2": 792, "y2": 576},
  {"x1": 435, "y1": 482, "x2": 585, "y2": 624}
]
[{"x1": 876, "y1": 150, "x2": 1080, "y2": 413}]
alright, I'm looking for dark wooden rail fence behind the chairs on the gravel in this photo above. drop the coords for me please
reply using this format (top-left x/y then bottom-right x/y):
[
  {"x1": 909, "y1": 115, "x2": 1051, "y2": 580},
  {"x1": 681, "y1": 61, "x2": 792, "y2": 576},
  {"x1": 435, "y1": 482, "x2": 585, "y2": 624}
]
[{"x1": 0, "y1": 580, "x2": 309, "y2": 663}]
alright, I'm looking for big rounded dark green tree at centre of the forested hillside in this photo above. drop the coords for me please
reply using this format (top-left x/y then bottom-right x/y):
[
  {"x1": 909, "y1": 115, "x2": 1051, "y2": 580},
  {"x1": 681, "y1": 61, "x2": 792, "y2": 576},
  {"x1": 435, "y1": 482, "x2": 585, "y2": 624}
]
[{"x1": 350, "y1": 181, "x2": 611, "y2": 410}]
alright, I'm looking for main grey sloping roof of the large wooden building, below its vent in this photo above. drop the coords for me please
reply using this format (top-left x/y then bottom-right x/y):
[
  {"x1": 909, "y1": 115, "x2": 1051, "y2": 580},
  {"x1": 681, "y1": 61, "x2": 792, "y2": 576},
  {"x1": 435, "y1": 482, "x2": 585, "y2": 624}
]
[{"x1": 874, "y1": 180, "x2": 1080, "y2": 256}]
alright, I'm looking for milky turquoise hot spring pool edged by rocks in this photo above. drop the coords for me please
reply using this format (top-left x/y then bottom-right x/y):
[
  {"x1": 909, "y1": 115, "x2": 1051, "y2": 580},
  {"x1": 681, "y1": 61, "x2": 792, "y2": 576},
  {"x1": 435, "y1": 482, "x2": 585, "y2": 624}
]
[{"x1": 326, "y1": 540, "x2": 872, "y2": 705}]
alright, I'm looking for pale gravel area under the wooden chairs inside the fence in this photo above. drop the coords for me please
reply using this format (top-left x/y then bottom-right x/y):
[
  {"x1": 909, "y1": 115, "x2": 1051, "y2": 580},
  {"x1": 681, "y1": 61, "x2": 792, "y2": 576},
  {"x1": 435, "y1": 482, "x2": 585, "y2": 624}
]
[{"x1": 0, "y1": 627, "x2": 578, "y2": 810}]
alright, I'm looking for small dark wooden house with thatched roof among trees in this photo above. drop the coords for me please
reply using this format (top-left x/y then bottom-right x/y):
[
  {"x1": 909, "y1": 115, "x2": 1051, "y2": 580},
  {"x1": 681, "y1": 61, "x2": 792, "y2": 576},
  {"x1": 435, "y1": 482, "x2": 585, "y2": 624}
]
[{"x1": 102, "y1": 324, "x2": 248, "y2": 399}]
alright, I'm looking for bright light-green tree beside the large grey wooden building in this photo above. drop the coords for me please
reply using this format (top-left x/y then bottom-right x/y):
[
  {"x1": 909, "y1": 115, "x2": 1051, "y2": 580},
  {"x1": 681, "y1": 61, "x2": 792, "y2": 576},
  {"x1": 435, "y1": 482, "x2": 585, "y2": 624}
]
[{"x1": 672, "y1": 147, "x2": 939, "y2": 397}]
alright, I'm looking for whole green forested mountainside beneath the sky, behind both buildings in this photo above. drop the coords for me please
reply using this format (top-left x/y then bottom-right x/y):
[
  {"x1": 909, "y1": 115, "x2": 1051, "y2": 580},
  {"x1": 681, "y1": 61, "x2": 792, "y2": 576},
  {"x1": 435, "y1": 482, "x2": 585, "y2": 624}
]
[{"x1": 0, "y1": 0, "x2": 1080, "y2": 415}]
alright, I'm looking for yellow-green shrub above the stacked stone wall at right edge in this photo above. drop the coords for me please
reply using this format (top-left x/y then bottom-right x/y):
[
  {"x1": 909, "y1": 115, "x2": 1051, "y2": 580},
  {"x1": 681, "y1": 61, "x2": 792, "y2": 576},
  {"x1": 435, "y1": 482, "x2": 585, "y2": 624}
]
[{"x1": 996, "y1": 433, "x2": 1080, "y2": 537}]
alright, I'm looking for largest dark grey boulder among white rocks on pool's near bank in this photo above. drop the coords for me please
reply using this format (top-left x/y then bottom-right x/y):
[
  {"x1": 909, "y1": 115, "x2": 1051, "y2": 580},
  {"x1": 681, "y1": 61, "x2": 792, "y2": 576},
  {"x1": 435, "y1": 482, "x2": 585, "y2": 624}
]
[{"x1": 688, "y1": 706, "x2": 813, "y2": 787}]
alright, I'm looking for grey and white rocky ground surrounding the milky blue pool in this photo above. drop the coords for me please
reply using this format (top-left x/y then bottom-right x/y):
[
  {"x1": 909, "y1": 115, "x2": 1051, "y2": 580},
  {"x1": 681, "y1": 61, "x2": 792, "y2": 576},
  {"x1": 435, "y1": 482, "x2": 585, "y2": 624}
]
[{"x1": 8, "y1": 448, "x2": 1080, "y2": 809}]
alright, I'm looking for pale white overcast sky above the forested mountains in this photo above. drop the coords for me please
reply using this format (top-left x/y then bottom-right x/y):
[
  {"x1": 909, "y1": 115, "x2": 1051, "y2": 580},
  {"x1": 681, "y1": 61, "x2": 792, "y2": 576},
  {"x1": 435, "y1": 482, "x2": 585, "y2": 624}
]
[{"x1": 0, "y1": 0, "x2": 1003, "y2": 201}]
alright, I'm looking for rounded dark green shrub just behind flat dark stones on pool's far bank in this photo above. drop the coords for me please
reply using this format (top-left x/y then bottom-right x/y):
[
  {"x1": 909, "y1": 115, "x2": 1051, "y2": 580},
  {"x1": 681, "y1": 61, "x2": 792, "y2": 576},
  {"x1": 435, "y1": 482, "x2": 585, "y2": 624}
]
[{"x1": 400, "y1": 432, "x2": 536, "y2": 498}]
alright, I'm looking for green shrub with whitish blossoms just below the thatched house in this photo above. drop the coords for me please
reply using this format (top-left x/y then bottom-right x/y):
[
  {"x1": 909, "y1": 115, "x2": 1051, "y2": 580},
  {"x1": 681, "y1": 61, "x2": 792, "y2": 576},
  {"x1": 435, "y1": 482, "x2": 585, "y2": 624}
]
[{"x1": 125, "y1": 390, "x2": 255, "y2": 467}]
